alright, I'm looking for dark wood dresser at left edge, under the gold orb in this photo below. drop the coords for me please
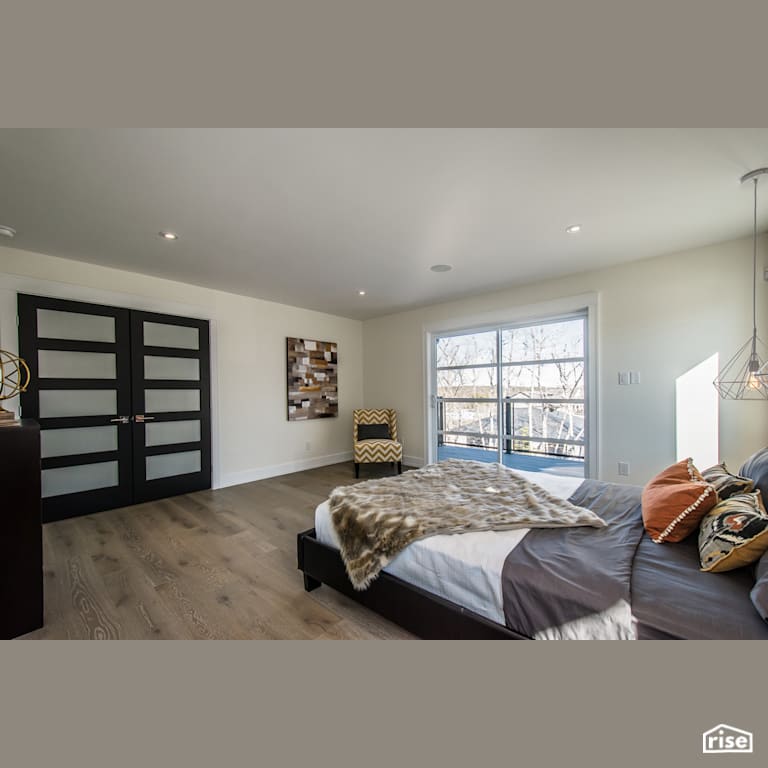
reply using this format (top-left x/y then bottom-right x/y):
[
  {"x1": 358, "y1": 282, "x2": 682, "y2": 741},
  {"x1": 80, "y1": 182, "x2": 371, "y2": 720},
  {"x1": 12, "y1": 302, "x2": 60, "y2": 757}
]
[{"x1": 0, "y1": 419, "x2": 43, "y2": 640}]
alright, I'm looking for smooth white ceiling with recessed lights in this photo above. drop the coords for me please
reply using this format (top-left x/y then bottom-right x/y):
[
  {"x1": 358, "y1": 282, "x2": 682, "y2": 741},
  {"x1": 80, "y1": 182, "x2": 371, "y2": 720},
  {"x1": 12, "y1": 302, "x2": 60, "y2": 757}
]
[{"x1": 0, "y1": 129, "x2": 768, "y2": 319}]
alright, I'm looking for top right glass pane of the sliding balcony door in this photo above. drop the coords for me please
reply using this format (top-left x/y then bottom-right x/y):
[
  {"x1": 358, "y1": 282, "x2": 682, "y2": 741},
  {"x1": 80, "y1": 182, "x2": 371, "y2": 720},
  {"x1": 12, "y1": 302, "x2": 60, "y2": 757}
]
[{"x1": 501, "y1": 318, "x2": 584, "y2": 363}]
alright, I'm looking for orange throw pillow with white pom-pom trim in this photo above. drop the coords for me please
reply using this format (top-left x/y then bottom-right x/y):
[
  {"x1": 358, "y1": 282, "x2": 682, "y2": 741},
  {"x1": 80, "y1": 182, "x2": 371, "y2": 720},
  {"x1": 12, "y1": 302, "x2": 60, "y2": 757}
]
[{"x1": 643, "y1": 459, "x2": 718, "y2": 544}]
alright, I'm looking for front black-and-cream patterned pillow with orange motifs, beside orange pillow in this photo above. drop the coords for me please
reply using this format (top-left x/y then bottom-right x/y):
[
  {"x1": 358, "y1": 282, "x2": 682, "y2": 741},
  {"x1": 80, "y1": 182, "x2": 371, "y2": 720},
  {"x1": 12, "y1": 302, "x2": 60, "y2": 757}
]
[{"x1": 699, "y1": 491, "x2": 768, "y2": 572}]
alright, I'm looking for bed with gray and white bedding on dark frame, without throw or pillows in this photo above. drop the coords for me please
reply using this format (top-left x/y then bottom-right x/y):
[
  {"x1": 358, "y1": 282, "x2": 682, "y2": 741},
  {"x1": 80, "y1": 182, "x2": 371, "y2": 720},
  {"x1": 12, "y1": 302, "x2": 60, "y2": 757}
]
[{"x1": 298, "y1": 464, "x2": 768, "y2": 639}]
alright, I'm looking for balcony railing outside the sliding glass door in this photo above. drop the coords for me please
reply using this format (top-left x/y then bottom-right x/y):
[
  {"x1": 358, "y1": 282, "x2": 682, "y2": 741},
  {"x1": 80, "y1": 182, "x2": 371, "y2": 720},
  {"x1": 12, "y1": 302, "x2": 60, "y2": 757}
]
[{"x1": 436, "y1": 397, "x2": 586, "y2": 459}]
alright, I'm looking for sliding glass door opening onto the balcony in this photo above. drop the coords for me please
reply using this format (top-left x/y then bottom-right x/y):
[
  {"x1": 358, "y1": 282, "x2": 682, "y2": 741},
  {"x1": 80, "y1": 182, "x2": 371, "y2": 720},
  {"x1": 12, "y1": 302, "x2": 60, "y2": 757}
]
[{"x1": 432, "y1": 312, "x2": 589, "y2": 477}]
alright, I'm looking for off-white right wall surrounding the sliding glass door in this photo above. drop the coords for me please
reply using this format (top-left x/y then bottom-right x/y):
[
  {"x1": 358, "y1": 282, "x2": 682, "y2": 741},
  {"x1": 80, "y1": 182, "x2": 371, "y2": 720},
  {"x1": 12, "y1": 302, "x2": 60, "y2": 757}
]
[{"x1": 363, "y1": 238, "x2": 768, "y2": 484}]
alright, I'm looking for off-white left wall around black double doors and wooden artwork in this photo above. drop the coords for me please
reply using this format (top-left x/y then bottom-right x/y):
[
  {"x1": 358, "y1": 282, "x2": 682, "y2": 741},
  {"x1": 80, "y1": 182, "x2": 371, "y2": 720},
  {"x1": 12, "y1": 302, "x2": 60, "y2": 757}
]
[{"x1": 0, "y1": 247, "x2": 363, "y2": 487}]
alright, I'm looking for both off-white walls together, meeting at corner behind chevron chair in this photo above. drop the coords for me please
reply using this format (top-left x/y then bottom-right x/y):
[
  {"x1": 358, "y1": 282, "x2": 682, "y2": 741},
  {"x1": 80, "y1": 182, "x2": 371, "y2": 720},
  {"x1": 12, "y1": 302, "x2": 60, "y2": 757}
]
[{"x1": 6, "y1": 234, "x2": 768, "y2": 487}]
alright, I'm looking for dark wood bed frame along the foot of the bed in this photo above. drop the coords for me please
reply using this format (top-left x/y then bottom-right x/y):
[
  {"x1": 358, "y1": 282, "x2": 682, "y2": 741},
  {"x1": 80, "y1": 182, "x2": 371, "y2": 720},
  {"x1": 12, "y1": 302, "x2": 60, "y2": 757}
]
[{"x1": 297, "y1": 528, "x2": 529, "y2": 640}]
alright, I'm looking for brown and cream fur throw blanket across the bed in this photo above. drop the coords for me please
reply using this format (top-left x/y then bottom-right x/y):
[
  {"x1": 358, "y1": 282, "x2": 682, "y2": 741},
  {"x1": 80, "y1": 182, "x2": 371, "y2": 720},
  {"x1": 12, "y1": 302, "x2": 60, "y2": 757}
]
[{"x1": 330, "y1": 459, "x2": 606, "y2": 590}]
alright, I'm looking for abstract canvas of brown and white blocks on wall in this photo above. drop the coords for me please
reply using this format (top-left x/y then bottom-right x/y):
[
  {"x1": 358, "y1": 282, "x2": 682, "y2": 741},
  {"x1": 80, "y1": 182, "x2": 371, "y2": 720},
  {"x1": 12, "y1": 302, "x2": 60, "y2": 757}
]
[{"x1": 286, "y1": 337, "x2": 339, "y2": 421}]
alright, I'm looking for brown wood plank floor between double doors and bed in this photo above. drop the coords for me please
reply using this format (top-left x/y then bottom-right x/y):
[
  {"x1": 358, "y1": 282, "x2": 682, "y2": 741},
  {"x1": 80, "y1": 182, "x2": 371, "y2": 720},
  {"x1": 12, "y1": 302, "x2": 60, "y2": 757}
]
[{"x1": 24, "y1": 462, "x2": 412, "y2": 640}]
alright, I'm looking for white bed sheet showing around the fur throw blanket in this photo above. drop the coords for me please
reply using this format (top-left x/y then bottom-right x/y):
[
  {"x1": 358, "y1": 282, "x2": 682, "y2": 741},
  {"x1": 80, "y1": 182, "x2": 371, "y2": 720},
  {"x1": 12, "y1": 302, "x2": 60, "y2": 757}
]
[{"x1": 315, "y1": 472, "x2": 582, "y2": 624}]
